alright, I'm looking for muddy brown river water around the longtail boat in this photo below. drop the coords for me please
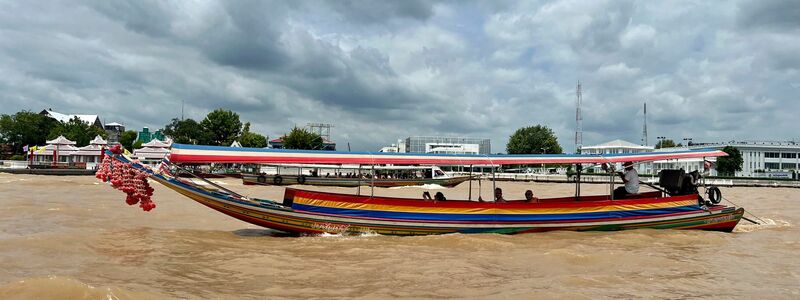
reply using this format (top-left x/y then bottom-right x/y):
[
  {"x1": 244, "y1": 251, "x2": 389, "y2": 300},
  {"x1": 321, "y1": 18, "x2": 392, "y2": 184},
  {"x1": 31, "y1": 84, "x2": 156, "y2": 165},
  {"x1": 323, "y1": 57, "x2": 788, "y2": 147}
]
[{"x1": 0, "y1": 174, "x2": 800, "y2": 299}]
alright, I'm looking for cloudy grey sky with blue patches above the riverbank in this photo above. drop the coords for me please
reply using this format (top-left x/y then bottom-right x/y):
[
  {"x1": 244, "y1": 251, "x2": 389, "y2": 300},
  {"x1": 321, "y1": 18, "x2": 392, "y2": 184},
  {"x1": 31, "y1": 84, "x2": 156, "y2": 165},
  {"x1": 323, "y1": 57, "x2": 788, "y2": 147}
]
[{"x1": 0, "y1": 0, "x2": 800, "y2": 152}]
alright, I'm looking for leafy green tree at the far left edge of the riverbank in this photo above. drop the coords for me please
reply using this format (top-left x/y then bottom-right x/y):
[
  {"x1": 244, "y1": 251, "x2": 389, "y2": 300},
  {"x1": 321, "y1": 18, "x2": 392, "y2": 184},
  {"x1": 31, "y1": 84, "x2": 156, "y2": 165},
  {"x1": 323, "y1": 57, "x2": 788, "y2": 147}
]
[{"x1": 0, "y1": 111, "x2": 58, "y2": 153}]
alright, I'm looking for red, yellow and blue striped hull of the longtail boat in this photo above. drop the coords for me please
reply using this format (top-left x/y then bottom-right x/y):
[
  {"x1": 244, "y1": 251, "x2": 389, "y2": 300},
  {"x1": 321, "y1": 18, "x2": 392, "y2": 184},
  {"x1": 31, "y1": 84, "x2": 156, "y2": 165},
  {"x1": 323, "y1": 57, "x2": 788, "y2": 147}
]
[{"x1": 147, "y1": 174, "x2": 744, "y2": 235}]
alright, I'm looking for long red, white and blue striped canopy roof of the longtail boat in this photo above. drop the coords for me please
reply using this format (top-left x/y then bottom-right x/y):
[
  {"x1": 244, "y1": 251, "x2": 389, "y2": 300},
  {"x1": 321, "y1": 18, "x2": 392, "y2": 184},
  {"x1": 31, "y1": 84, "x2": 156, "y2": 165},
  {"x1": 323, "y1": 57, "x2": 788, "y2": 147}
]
[{"x1": 169, "y1": 144, "x2": 727, "y2": 165}]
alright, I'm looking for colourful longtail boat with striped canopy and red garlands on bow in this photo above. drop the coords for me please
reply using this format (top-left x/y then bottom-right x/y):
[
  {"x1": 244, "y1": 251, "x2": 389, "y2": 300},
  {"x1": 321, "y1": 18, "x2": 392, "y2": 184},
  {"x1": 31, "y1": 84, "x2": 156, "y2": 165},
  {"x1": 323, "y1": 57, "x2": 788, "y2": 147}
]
[{"x1": 97, "y1": 144, "x2": 745, "y2": 235}]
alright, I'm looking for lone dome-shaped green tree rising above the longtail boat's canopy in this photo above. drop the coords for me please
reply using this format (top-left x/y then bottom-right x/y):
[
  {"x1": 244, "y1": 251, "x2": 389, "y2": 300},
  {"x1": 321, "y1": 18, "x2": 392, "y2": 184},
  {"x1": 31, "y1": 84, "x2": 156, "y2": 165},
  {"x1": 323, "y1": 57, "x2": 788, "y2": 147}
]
[{"x1": 506, "y1": 125, "x2": 562, "y2": 154}]
